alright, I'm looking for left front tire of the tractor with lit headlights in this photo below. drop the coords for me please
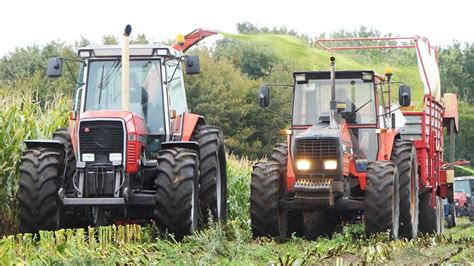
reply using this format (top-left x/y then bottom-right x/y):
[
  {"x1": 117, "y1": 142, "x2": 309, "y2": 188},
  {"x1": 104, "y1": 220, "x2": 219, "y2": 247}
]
[{"x1": 250, "y1": 162, "x2": 287, "y2": 238}]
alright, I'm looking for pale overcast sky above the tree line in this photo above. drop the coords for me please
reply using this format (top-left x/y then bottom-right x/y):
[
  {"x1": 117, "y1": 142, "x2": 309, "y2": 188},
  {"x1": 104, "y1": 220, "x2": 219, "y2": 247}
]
[{"x1": 0, "y1": 0, "x2": 474, "y2": 56}]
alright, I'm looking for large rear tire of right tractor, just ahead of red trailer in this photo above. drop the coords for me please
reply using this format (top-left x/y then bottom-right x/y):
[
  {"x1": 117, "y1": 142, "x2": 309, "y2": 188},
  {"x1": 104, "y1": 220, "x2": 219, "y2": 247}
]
[{"x1": 392, "y1": 139, "x2": 419, "y2": 239}]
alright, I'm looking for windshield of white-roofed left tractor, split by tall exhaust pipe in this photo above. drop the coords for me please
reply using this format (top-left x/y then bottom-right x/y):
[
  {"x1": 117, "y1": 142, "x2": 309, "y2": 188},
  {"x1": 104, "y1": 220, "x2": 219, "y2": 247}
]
[{"x1": 84, "y1": 59, "x2": 165, "y2": 134}]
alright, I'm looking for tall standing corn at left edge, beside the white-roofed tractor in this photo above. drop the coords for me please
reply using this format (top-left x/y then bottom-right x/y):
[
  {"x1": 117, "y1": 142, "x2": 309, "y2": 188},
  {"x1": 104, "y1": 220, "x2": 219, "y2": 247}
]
[{"x1": 0, "y1": 90, "x2": 70, "y2": 235}]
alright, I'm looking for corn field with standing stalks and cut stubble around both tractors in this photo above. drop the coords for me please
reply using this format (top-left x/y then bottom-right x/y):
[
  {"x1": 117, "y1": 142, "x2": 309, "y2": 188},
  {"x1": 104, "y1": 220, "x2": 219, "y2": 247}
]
[{"x1": 0, "y1": 90, "x2": 474, "y2": 265}]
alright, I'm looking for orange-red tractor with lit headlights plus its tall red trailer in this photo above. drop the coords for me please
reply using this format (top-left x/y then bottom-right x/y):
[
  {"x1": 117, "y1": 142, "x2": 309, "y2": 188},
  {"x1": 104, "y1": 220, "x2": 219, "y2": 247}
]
[{"x1": 250, "y1": 37, "x2": 457, "y2": 239}]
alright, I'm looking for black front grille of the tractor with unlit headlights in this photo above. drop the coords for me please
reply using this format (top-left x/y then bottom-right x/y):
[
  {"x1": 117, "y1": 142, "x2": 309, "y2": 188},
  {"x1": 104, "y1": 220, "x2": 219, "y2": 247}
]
[{"x1": 79, "y1": 121, "x2": 124, "y2": 161}]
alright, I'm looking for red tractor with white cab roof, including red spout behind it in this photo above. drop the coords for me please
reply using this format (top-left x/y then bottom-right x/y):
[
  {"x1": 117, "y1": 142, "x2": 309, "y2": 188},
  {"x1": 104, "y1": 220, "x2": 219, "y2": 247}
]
[{"x1": 18, "y1": 26, "x2": 227, "y2": 238}]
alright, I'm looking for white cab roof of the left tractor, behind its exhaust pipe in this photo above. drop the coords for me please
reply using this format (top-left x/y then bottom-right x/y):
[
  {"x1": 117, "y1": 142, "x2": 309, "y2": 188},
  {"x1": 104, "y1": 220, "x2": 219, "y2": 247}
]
[{"x1": 77, "y1": 44, "x2": 181, "y2": 58}]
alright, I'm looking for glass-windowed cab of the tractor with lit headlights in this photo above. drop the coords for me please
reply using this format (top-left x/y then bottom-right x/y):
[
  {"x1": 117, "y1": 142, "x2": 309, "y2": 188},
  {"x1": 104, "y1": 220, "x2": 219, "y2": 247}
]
[{"x1": 292, "y1": 71, "x2": 378, "y2": 160}]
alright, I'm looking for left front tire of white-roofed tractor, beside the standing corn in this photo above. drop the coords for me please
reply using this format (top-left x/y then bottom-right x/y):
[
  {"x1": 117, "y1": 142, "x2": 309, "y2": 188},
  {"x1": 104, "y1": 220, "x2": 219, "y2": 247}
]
[{"x1": 17, "y1": 148, "x2": 63, "y2": 233}]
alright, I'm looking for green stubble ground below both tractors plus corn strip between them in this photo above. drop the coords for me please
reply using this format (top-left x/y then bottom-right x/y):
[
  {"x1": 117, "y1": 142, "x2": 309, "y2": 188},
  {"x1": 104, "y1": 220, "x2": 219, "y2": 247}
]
[{"x1": 0, "y1": 155, "x2": 474, "y2": 265}]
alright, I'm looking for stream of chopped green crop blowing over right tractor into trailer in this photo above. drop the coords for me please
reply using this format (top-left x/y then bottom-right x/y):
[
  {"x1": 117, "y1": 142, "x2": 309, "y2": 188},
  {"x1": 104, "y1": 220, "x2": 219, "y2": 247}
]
[{"x1": 222, "y1": 33, "x2": 423, "y2": 108}]
